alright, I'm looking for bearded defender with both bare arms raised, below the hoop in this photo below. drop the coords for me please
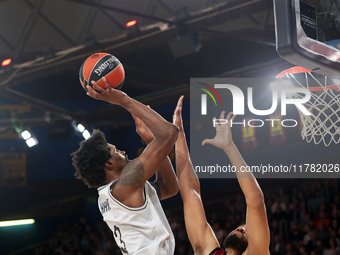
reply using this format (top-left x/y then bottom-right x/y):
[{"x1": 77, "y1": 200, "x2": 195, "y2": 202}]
[{"x1": 173, "y1": 97, "x2": 270, "y2": 255}]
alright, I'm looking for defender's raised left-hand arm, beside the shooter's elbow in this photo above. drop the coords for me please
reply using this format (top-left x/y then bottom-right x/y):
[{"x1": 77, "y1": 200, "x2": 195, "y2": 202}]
[{"x1": 173, "y1": 96, "x2": 219, "y2": 255}]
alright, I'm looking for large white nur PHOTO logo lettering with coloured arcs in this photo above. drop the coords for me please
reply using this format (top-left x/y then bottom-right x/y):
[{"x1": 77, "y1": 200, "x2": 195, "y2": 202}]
[{"x1": 191, "y1": 78, "x2": 311, "y2": 128}]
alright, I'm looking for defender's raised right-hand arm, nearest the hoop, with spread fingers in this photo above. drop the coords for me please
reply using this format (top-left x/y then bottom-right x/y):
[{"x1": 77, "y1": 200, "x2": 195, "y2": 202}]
[{"x1": 202, "y1": 112, "x2": 270, "y2": 254}]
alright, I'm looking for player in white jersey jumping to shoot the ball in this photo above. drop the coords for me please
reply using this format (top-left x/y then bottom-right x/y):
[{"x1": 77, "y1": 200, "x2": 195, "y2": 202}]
[{"x1": 72, "y1": 79, "x2": 178, "y2": 255}]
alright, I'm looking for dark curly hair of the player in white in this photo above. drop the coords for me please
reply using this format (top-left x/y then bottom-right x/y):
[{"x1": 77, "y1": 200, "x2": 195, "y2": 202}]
[{"x1": 71, "y1": 129, "x2": 111, "y2": 188}]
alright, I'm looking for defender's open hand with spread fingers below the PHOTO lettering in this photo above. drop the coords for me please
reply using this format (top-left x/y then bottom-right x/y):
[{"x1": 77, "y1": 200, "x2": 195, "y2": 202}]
[{"x1": 202, "y1": 111, "x2": 236, "y2": 150}]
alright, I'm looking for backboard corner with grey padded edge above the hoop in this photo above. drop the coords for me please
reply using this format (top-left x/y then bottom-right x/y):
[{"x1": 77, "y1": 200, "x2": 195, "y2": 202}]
[{"x1": 274, "y1": 0, "x2": 340, "y2": 78}]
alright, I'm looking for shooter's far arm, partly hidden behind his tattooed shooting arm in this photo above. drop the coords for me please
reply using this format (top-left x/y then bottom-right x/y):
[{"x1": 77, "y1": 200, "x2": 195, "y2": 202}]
[{"x1": 132, "y1": 112, "x2": 179, "y2": 199}]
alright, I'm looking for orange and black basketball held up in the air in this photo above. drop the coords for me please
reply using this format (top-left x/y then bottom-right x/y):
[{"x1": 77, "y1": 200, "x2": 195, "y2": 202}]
[{"x1": 79, "y1": 52, "x2": 125, "y2": 92}]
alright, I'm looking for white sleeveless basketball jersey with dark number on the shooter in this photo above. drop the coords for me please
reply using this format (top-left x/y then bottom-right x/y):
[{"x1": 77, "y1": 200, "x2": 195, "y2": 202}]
[{"x1": 98, "y1": 180, "x2": 175, "y2": 255}]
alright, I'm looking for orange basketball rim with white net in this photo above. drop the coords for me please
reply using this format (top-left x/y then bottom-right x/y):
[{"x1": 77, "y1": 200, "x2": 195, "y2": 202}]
[{"x1": 276, "y1": 66, "x2": 340, "y2": 146}]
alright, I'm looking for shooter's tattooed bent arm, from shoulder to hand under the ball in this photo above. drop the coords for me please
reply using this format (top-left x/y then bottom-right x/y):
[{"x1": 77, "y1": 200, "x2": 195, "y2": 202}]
[{"x1": 87, "y1": 78, "x2": 178, "y2": 207}]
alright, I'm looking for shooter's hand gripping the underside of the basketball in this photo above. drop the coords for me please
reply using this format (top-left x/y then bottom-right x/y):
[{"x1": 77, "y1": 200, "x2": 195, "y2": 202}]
[{"x1": 86, "y1": 77, "x2": 127, "y2": 105}]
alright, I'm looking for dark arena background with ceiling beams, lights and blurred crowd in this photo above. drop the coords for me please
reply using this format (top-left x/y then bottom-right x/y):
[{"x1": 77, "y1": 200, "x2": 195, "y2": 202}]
[{"x1": 0, "y1": 0, "x2": 340, "y2": 254}]
